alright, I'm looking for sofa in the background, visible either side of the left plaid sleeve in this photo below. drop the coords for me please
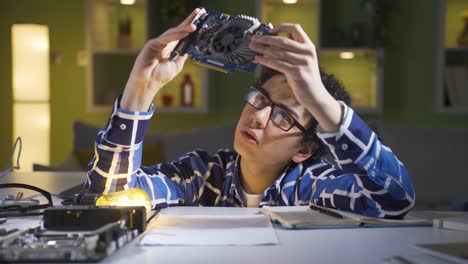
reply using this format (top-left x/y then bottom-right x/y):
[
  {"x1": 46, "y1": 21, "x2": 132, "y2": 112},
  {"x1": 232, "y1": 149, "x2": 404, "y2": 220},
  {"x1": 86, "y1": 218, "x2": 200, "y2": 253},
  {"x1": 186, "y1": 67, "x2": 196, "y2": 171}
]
[{"x1": 34, "y1": 121, "x2": 237, "y2": 171}]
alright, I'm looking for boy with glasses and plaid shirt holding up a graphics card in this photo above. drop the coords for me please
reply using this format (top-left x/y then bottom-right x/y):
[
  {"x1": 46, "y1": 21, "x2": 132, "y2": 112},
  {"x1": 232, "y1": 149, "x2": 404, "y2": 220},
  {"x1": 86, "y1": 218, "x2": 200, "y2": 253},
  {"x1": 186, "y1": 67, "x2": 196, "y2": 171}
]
[{"x1": 85, "y1": 9, "x2": 415, "y2": 218}]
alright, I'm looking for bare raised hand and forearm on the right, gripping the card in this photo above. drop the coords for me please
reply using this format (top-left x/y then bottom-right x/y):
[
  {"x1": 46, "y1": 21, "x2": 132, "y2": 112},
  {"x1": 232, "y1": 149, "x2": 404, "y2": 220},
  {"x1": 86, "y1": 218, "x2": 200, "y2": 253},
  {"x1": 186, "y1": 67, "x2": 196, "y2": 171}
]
[{"x1": 250, "y1": 23, "x2": 342, "y2": 132}]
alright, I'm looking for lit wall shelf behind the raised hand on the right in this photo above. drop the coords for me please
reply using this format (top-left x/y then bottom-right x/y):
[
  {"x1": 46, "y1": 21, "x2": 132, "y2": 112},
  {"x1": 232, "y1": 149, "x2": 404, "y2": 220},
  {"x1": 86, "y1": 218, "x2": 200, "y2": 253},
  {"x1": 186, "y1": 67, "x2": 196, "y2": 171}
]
[{"x1": 258, "y1": 0, "x2": 384, "y2": 113}]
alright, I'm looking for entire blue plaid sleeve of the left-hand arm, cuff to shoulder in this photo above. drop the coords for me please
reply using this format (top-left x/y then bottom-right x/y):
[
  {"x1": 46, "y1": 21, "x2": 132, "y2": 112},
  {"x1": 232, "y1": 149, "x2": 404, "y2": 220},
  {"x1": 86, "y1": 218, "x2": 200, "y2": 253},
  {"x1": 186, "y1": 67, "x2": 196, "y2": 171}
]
[{"x1": 85, "y1": 97, "x2": 230, "y2": 207}]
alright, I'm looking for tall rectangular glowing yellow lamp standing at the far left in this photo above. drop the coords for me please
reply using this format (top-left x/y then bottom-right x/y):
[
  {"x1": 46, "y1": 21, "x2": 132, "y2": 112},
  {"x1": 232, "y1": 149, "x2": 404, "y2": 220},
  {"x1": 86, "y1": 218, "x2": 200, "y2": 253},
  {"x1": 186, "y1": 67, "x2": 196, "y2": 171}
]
[{"x1": 11, "y1": 24, "x2": 50, "y2": 171}]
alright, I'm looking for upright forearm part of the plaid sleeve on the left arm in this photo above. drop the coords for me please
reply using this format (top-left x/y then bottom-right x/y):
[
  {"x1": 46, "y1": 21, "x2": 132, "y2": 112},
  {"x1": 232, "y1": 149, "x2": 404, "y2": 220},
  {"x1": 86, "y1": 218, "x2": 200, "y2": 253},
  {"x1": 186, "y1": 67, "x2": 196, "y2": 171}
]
[{"x1": 85, "y1": 96, "x2": 155, "y2": 193}]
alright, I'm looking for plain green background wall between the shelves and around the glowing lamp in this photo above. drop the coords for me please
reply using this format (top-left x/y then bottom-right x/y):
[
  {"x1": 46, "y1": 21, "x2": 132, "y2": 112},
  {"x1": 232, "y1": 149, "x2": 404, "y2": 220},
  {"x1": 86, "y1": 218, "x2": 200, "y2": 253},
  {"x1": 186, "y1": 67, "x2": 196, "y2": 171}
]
[{"x1": 0, "y1": 0, "x2": 468, "y2": 168}]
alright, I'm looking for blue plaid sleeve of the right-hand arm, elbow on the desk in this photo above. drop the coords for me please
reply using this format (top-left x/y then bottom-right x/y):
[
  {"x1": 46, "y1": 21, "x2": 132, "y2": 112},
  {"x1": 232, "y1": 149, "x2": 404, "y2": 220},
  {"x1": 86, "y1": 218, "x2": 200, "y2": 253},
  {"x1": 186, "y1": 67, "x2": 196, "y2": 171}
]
[{"x1": 307, "y1": 103, "x2": 415, "y2": 218}]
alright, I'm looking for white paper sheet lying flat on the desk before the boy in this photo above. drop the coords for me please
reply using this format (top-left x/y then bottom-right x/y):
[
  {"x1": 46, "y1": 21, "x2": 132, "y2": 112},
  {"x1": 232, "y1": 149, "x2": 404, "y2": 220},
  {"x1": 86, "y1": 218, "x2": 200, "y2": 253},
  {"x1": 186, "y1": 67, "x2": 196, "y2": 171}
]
[{"x1": 140, "y1": 211, "x2": 278, "y2": 246}]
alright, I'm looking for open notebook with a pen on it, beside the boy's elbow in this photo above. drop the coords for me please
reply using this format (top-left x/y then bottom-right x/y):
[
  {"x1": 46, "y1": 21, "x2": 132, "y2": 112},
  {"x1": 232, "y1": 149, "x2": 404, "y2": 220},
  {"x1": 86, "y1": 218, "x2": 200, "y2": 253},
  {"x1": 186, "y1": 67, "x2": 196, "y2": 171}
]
[{"x1": 262, "y1": 205, "x2": 432, "y2": 229}]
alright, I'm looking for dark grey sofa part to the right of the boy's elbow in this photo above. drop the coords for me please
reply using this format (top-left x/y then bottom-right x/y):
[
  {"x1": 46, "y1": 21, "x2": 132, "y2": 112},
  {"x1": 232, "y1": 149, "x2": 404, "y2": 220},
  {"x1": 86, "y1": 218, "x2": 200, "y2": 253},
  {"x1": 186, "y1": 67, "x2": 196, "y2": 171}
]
[{"x1": 377, "y1": 122, "x2": 468, "y2": 209}]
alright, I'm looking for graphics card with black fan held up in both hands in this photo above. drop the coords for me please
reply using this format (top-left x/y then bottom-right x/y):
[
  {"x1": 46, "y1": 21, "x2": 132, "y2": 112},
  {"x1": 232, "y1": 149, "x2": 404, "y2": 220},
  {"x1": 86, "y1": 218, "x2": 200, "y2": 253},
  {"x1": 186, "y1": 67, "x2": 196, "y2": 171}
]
[{"x1": 171, "y1": 10, "x2": 273, "y2": 72}]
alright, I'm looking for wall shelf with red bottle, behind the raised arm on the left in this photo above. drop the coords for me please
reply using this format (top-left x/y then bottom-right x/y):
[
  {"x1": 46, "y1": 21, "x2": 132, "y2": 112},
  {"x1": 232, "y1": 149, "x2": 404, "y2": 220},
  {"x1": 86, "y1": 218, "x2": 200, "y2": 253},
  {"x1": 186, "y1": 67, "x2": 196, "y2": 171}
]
[{"x1": 85, "y1": 0, "x2": 208, "y2": 113}]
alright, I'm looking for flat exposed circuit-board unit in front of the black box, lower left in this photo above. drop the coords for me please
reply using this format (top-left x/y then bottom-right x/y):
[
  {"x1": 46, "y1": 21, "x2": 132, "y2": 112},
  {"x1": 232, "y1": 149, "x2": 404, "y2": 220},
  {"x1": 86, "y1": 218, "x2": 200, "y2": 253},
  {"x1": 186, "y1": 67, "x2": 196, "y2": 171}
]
[{"x1": 0, "y1": 222, "x2": 138, "y2": 263}]
